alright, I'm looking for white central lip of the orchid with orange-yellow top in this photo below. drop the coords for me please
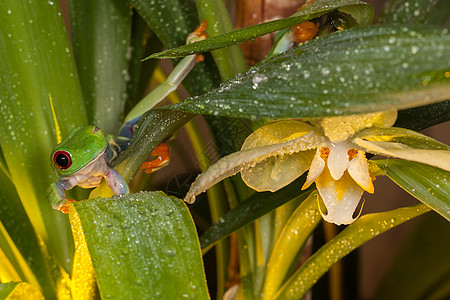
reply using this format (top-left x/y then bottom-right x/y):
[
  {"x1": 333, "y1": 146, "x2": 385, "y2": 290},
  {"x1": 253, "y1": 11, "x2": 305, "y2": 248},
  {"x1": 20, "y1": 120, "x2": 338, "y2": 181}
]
[{"x1": 316, "y1": 169, "x2": 364, "y2": 225}]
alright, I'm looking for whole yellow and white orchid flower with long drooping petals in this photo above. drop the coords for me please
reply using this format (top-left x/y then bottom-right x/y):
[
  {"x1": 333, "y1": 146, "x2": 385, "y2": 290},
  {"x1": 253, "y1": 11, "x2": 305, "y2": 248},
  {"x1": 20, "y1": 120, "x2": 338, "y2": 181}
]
[{"x1": 185, "y1": 110, "x2": 450, "y2": 225}]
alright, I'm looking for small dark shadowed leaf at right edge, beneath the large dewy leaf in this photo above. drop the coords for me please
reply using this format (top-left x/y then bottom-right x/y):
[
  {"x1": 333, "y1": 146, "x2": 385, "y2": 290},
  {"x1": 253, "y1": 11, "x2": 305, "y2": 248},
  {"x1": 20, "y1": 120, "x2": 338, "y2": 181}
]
[{"x1": 394, "y1": 100, "x2": 450, "y2": 131}]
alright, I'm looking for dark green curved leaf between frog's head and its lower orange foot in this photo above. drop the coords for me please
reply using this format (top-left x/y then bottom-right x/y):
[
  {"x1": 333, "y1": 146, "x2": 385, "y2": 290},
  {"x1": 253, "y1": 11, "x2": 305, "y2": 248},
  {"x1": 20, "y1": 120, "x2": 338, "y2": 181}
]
[{"x1": 116, "y1": 108, "x2": 195, "y2": 182}]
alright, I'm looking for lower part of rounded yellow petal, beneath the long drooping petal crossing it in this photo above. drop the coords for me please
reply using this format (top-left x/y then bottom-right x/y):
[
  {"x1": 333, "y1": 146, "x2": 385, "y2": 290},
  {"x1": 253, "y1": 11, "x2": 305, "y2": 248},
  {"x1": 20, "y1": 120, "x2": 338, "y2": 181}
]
[{"x1": 241, "y1": 150, "x2": 314, "y2": 192}]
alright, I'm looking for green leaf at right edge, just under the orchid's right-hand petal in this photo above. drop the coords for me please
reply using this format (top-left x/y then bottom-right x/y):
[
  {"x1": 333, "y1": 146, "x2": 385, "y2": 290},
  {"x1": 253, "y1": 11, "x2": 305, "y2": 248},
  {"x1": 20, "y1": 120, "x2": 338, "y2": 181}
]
[{"x1": 372, "y1": 159, "x2": 450, "y2": 221}]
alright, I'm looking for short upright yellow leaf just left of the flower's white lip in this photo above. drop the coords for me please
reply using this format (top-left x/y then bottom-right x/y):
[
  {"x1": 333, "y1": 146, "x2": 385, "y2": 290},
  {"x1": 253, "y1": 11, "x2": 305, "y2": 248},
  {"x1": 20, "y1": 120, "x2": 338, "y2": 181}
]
[{"x1": 264, "y1": 192, "x2": 322, "y2": 299}]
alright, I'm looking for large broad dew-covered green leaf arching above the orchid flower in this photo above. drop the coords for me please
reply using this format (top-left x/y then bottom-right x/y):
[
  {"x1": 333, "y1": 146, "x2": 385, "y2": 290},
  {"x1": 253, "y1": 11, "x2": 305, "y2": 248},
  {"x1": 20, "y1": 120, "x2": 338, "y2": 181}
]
[{"x1": 171, "y1": 25, "x2": 450, "y2": 119}]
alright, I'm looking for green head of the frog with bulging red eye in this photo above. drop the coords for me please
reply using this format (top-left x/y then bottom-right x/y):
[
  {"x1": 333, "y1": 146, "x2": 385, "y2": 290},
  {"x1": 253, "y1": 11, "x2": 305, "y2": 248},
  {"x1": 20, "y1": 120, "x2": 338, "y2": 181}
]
[{"x1": 50, "y1": 126, "x2": 107, "y2": 178}]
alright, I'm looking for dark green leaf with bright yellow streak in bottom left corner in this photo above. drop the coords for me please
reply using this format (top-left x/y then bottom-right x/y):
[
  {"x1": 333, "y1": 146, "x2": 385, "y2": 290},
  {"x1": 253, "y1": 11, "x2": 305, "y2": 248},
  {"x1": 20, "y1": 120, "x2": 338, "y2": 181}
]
[{"x1": 0, "y1": 170, "x2": 55, "y2": 299}]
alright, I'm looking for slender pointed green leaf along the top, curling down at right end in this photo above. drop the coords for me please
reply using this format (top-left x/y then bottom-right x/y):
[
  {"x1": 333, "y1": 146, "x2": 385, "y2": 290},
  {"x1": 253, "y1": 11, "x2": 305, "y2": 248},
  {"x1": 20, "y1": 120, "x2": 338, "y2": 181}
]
[{"x1": 147, "y1": 0, "x2": 373, "y2": 59}]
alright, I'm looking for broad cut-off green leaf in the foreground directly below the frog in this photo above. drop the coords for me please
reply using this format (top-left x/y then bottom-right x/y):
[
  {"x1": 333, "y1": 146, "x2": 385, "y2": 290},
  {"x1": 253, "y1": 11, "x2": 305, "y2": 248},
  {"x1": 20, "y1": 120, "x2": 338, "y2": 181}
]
[{"x1": 75, "y1": 192, "x2": 209, "y2": 299}]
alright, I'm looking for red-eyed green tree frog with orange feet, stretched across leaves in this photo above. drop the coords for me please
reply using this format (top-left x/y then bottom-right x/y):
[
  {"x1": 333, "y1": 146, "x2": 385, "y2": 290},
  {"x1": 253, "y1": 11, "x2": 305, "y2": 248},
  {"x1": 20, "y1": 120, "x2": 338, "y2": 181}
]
[{"x1": 47, "y1": 21, "x2": 207, "y2": 213}]
